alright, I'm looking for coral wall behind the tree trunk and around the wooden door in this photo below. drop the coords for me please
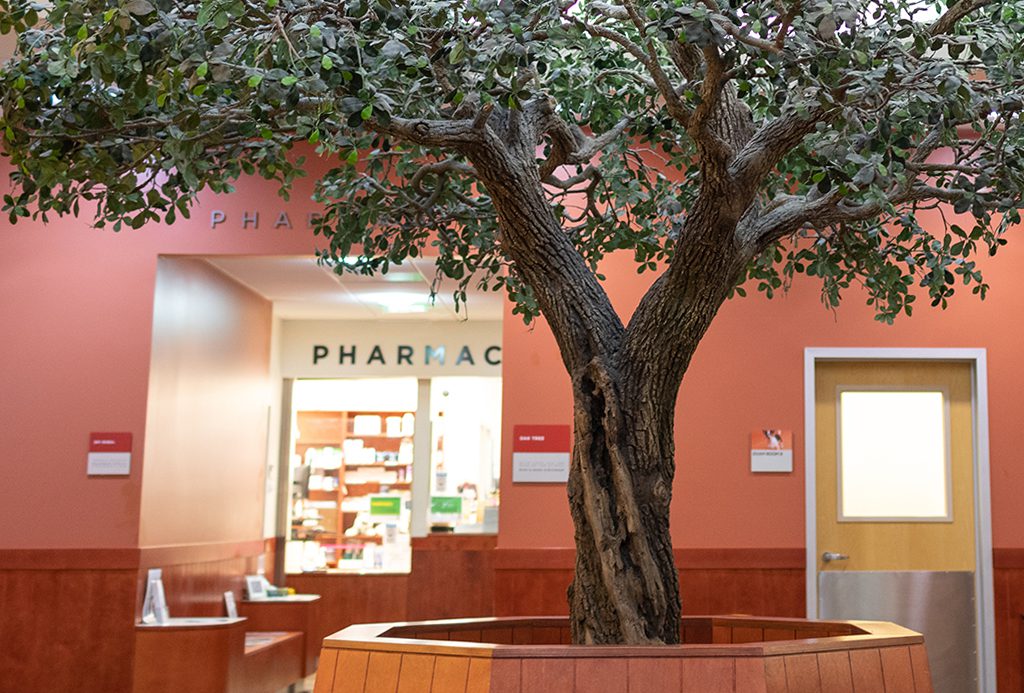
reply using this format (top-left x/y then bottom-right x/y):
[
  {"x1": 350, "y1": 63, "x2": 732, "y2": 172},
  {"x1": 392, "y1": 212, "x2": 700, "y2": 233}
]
[{"x1": 499, "y1": 219, "x2": 1024, "y2": 548}]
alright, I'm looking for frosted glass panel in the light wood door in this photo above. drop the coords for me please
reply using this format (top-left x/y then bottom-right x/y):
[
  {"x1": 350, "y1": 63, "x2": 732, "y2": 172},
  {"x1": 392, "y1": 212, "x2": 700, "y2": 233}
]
[{"x1": 839, "y1": 390, "x2": 951, "y2": 521}]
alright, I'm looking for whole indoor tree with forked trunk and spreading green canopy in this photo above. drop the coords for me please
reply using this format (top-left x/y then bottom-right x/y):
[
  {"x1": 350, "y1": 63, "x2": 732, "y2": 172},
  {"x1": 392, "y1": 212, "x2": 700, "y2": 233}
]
[{"x1": 0, "y1": 0, "x2": 1024, "y2": 643}]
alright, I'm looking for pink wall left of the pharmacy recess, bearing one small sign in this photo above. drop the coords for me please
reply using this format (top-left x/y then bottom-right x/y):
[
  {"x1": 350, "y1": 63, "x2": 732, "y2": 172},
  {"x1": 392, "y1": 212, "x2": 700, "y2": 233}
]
[{"x1": 0, "y1": 164, "x2": 315, "y2": 549}]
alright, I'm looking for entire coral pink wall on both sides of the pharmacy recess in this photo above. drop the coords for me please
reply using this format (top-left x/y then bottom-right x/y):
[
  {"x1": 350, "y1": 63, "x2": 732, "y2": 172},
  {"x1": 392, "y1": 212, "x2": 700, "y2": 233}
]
[{"x1": 0, "y1": 148, "x2": 1024, "y2": 548}]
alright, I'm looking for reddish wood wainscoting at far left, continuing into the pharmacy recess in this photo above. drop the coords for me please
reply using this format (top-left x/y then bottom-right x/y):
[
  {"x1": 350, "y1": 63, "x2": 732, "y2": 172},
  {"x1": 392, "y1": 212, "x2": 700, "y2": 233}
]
[{"x1": 0, "y1": 539, "x2": 274, "y2": 693}]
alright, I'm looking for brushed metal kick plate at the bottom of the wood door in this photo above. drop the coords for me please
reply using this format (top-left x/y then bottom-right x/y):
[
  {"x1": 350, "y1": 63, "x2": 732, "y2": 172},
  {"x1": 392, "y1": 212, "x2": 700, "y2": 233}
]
[{"x1": 818, "y1": 570, "x2": 978, "y2": 693}]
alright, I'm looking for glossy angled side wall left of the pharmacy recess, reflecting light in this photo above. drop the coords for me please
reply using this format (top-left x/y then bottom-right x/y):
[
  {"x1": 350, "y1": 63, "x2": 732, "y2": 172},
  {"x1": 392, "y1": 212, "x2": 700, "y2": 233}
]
[{"x1": 139, "y1": 257, "x2": 272, "y2": 547}]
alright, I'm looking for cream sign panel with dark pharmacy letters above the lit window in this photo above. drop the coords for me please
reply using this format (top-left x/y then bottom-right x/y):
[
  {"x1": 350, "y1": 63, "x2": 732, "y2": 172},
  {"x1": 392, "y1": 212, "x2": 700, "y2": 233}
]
[{"x1": 282, "y1": 320, "x2": 502, "y2": 378}]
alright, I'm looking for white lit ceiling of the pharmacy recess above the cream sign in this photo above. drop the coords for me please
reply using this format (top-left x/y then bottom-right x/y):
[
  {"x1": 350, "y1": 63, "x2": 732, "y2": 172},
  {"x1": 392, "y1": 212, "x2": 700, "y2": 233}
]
[{"x1": 204, "y1": 255, "x2": 505, "y2": 320}]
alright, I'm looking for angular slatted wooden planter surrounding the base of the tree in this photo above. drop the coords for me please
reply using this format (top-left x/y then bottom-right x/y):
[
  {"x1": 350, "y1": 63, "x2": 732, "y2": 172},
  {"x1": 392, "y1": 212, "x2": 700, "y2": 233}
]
[{"x1": 314, "y1": 616, "x2": 932, "y2": 693}]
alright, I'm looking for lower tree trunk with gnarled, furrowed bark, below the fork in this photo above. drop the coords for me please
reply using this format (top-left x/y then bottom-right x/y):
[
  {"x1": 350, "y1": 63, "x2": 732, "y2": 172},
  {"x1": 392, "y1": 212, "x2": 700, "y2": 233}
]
[{"x1": 568, "y1": 359, "x2": 681, "y2": 644}]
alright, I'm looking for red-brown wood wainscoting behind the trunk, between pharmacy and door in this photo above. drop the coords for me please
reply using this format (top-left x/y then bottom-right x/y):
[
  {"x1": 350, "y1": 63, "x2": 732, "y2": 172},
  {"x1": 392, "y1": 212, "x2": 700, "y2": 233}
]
[{"x1": 495, "y1": 549, "x2": 806, "y2": 617}]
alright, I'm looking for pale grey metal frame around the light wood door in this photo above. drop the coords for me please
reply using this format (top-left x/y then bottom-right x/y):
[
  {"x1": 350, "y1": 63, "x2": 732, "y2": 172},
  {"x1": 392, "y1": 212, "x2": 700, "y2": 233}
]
[{"x1": 804, "y1": 347, "x2": 995, "y2": 693}]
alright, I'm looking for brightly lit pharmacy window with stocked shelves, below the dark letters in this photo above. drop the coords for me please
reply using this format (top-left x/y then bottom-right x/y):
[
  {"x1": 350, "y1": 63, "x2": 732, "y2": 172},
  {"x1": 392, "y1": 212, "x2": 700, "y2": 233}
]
[{"x1": 285, "y1": 376, "x2": 501, "y2": 573}]
